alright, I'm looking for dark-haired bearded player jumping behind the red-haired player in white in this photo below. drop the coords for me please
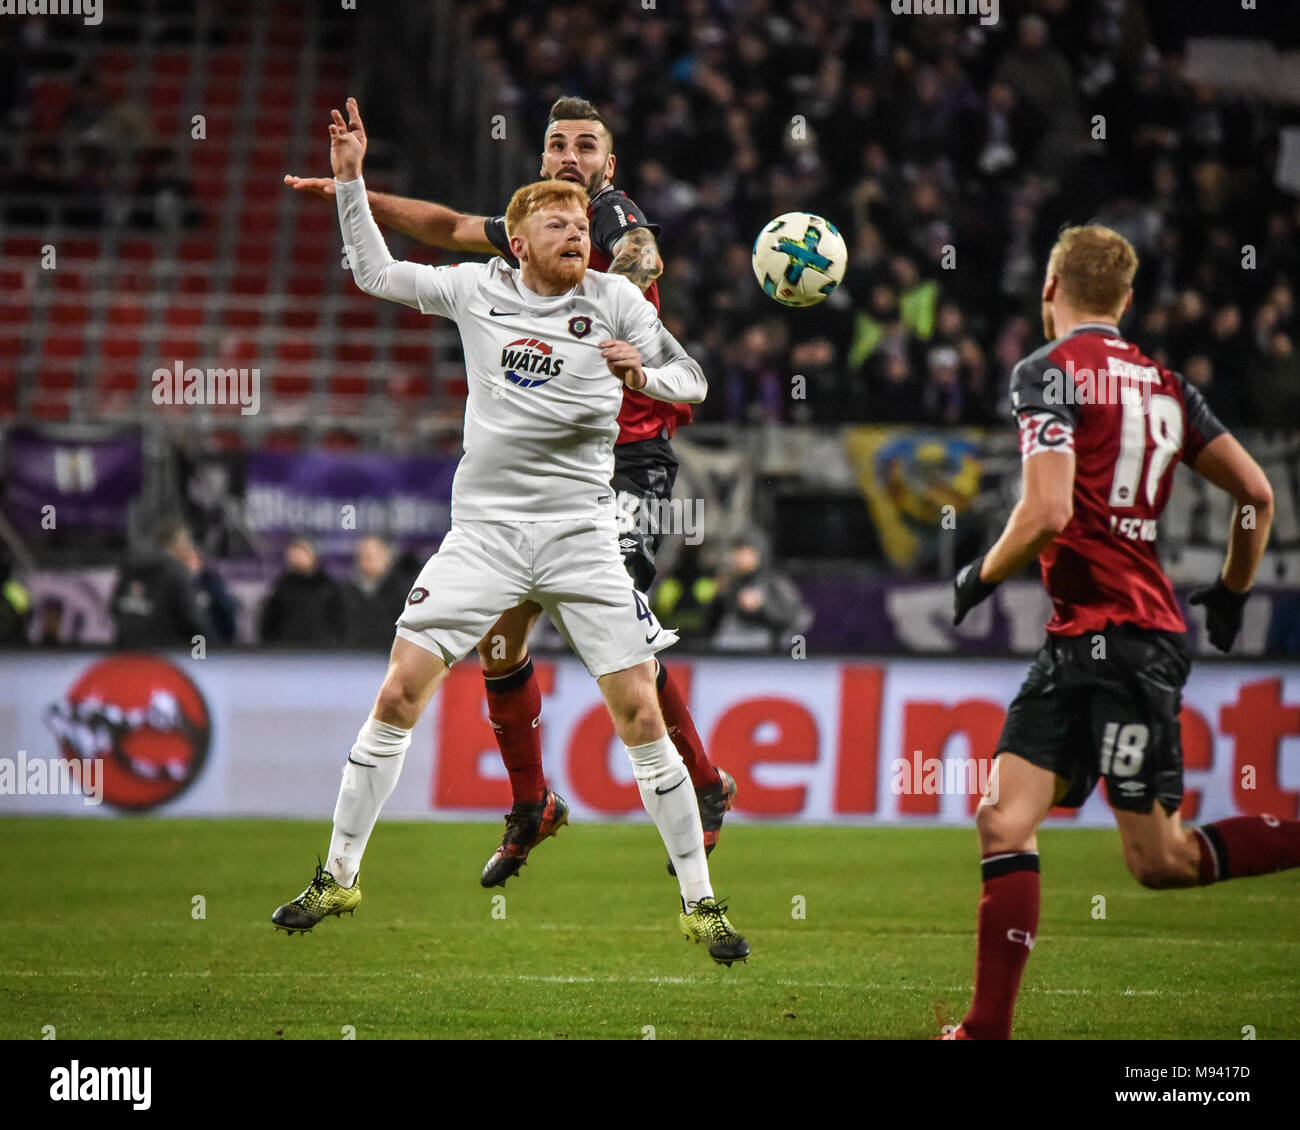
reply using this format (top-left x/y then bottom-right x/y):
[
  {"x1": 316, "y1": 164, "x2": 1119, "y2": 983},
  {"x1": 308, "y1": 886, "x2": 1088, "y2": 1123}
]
[{"x1": 285, "y1": 98, "x2": 736, "y2": 887}]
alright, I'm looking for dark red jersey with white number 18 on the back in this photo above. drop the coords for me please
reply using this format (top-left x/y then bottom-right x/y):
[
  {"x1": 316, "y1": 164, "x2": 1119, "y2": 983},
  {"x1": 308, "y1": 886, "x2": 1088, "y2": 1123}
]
[{"x1": 1011, "y1": 324, "x2": 1226, "y2": 636}]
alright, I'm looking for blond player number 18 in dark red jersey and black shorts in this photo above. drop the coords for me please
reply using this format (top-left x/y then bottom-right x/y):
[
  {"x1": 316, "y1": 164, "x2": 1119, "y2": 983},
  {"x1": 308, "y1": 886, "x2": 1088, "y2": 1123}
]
[{"x1": 943, "y1": 225, "x2": 1300, "y2": 1039}]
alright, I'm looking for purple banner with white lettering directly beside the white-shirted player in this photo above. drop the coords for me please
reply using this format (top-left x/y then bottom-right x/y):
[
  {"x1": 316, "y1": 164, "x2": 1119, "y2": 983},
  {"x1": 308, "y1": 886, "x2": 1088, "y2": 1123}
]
[{"x1": 244, "y1": 451, "x2": 456, "y2": 558}]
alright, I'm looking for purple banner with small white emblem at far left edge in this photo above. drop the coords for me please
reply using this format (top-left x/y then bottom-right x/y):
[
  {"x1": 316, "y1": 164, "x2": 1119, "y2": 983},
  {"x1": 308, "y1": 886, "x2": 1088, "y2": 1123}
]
[{"x1": 4, "y1": 428, "x2": 143, "y2": 536}]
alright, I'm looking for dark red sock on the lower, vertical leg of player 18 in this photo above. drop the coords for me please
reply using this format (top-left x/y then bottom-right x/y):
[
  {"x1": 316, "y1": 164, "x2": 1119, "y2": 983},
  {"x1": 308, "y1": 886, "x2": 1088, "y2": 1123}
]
[{"x1": 962, "y1": 852, "x2": 1039, "y2": 1040}]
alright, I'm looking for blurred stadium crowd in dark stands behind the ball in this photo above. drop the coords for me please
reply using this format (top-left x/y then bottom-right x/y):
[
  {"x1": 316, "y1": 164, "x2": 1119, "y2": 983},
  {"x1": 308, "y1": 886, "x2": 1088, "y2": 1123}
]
[{"x1": 462, "y1": 0, "x2": 1300, "y2": 427}]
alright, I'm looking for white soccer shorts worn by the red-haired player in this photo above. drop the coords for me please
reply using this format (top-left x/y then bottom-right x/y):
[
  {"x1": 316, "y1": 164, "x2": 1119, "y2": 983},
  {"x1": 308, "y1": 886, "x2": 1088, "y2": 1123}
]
[{"x1": 397, "y1": 515, "x2": 677, "y2": 679}]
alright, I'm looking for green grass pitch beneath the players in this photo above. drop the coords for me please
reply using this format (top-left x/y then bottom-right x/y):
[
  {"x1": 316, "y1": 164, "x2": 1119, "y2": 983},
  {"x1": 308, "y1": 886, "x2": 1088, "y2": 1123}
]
[{"x1": 0, "y1": 819, "x2": 1300, "y2": 1040}]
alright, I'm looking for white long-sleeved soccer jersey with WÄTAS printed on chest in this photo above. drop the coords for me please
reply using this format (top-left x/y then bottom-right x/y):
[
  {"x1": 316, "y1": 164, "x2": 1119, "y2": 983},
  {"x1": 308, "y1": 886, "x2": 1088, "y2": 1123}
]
[{"x1": 334, "y1": 178, "x2": 707, "y2": 521}]
